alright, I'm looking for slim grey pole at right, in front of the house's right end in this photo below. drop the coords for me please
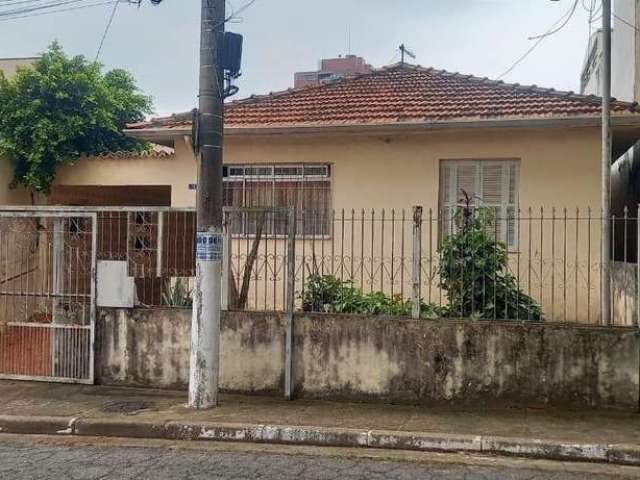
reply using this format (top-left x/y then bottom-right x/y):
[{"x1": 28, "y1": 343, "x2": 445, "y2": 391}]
[{"x1": 600, "y1": 0, "x2": 611, "y2": 325}]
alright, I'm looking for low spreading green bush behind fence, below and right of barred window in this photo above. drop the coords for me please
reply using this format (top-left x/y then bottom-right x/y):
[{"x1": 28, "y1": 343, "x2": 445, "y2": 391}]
[{"x1": 301, "y1": 274, "x2": 442, "y2": 318}]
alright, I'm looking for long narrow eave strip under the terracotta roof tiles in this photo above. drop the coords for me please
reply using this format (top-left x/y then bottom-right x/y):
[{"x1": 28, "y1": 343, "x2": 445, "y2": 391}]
[{"x1": 125, "y1": 114, "x2": 640, "y2": 144}]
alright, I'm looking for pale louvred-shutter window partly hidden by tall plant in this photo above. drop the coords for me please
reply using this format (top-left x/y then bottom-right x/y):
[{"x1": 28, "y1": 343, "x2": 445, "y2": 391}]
[{"x1": 439, "y1": 160, "x2": 520, "y2": 249}]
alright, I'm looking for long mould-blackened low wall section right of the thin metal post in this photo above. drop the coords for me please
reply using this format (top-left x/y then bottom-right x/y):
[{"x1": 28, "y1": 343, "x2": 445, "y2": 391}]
[{"x1": 294, "y1": 315, "x2": 640, "y2": 407}]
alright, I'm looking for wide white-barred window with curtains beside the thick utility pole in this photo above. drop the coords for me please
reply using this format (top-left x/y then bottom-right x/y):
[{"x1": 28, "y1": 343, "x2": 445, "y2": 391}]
[{"x1": 223, "y1": 164, "x2": 331, "y2": 236}]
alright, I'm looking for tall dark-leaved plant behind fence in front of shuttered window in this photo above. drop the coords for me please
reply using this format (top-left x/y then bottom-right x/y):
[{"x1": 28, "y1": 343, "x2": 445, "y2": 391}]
[{"x1": 439, "y1": 192, "x2": 542, "y2": 321}]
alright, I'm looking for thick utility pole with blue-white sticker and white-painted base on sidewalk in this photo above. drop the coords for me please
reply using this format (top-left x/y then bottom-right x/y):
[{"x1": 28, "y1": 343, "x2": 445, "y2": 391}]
[{"x1": 189, "y1": 0, "x2": 225, "y2": 409}]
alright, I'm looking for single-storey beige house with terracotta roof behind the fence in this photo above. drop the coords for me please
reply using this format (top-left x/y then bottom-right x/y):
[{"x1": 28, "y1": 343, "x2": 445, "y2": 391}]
[{"x1": 3, "y1": 64, "x2": 640, "y2": 323}]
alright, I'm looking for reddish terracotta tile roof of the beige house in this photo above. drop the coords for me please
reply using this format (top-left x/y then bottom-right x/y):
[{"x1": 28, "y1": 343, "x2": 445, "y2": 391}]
[{"x1": 129, "y1": 65, "x2": 639, "y2": 129}]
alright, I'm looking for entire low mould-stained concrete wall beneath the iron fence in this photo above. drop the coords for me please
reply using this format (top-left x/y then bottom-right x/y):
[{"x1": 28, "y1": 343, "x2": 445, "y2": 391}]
[{"x1": 97, "y1": 309, "x2": 640, "y2": 408}]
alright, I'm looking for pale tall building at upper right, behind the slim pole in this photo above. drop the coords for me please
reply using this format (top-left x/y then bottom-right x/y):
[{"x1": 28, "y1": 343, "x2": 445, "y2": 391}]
[{"x1": 580, "y1": 0, "x2": 640, "y2": 102}]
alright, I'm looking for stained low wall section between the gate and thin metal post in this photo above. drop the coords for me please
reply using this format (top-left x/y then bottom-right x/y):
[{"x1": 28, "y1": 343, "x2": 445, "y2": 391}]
[{"x1": 96, "y1": 308, "x2": 284, "y2": 393}]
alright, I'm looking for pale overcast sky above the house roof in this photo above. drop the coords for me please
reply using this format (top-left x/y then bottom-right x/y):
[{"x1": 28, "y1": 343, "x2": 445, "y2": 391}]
[{"x1": 0, "y1": 0, "x2": 608, "y2": 115}]
